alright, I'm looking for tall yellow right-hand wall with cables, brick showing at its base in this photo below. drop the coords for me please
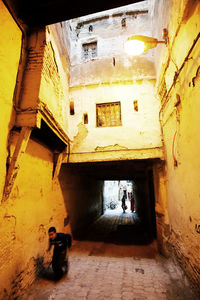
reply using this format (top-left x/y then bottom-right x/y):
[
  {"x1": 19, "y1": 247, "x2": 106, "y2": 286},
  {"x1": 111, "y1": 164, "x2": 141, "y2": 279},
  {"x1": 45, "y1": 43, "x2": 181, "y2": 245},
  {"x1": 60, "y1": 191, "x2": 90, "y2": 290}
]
[{"x1": 154, "y1": 1, "x2": 200, "y2": 290}]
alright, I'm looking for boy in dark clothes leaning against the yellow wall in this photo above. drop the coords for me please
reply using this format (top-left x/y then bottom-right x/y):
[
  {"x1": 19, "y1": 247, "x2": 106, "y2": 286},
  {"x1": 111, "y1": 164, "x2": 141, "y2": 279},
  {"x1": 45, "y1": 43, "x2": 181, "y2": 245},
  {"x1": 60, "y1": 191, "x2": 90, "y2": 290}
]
[{"x1": 47, "y1": 227, "x2": 72, "y2": 280}]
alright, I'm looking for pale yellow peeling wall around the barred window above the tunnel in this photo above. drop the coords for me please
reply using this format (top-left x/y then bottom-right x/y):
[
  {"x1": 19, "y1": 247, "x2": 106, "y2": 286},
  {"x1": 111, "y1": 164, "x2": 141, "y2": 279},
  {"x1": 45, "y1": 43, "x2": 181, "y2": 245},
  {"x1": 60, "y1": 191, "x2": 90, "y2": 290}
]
[{"x1": 68, "y1": 80, "x2": 162, "y2": 161}]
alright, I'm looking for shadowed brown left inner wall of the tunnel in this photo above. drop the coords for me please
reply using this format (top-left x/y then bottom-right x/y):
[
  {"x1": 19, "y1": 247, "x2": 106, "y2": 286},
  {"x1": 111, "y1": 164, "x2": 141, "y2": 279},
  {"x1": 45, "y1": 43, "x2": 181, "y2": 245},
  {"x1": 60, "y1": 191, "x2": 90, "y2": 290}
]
[{"x1": 59, "y1": 164, "x2": 103, "y2": 238}]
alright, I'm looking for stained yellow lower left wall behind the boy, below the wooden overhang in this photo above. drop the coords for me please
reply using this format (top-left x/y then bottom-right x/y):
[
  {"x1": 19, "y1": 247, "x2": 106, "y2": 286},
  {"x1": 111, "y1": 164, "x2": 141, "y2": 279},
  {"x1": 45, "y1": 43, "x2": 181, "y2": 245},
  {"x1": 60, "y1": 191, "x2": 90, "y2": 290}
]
[{"x1": 0, "y1": 132, "x2": 70, "y2": 299}]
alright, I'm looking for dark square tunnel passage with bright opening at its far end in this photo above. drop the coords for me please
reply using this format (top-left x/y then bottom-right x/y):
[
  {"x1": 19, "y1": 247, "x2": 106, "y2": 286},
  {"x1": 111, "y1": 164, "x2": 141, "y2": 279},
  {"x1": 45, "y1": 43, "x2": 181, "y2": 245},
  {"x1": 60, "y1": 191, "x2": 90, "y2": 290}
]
[{"x1": 60, "y1": 160, "x2": 156, "y2": 244}]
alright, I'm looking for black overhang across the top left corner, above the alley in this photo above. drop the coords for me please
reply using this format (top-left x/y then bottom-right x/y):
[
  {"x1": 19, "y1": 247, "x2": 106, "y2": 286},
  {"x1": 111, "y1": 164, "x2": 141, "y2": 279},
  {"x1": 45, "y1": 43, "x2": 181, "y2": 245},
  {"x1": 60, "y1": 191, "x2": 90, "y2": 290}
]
[{"x1": 4, "y1": 0, "x2": 143, "y2": 26}]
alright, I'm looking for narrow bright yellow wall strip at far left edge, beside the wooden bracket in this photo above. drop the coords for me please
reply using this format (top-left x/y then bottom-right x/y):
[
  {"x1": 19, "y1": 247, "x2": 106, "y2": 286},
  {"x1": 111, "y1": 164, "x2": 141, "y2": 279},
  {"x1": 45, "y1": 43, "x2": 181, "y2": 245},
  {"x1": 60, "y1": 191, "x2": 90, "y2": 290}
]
[{"x1": 0, "y1": 0, "x2": 22, "y2": 199}]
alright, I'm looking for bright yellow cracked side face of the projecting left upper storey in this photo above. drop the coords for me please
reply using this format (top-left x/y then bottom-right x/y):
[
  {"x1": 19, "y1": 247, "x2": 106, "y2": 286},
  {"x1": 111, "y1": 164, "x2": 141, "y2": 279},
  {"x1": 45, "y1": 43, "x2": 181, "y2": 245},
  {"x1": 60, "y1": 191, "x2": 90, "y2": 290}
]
[{"x1": 39, "y1": 23, "x2": 69, "y2": 132}]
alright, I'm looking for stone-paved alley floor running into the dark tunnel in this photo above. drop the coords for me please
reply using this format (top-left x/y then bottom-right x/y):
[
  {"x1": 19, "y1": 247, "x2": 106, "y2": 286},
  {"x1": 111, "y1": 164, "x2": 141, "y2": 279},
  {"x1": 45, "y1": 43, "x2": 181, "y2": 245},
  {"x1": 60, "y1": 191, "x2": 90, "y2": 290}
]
[{"x1": 22, "y1": 213, "x2": 198, "y2": 300}]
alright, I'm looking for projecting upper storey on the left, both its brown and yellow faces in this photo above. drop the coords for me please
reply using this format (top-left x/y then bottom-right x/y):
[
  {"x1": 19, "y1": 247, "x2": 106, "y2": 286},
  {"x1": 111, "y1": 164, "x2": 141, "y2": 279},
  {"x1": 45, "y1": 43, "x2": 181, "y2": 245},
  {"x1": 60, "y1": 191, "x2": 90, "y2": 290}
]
[{"x1": 18, "y1": 23, "x2": 69, "y2": 134}]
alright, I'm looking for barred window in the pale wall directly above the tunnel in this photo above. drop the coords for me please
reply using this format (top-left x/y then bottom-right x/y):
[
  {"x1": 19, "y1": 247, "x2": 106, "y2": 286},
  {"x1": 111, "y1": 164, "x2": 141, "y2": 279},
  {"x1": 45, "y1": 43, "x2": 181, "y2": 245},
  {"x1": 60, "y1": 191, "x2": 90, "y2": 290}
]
[{"x1": 96, "y1": 102, "x2": 121, "y2": 127}]
